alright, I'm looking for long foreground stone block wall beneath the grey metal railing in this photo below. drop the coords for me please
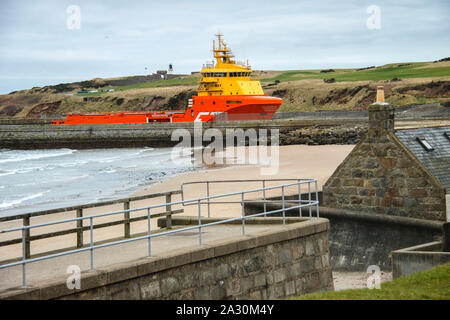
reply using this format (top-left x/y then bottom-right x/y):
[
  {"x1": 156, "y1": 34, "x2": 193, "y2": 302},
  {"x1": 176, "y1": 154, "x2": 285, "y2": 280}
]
[{"x1": 0, "y1": 218, "x2": 333, "y2": 299}]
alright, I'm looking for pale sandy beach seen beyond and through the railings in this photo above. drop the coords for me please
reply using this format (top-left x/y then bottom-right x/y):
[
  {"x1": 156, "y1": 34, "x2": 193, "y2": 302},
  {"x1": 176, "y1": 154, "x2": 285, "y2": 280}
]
[{"x1": 0, "y1": 145, "x2": 370, "y2": 289}]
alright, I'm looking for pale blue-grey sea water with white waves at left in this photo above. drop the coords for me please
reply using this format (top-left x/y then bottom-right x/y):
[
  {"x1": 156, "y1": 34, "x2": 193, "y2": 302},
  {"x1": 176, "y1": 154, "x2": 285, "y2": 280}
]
[{"x1": 0, "y1": 147, "x2": 195, "y2": 216}]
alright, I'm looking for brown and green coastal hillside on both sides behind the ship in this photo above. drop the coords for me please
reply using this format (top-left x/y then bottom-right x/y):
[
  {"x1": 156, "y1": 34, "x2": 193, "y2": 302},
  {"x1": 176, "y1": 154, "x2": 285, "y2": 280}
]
[{"x1": 0, "y1": 61, "x2": 450, "y2": 118}]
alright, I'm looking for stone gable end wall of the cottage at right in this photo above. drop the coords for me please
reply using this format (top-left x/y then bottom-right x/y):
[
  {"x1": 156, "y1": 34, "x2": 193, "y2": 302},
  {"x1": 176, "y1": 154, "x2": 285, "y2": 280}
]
[{"x1": 323, "y1": 105, "x2": 446, "y2": 221}]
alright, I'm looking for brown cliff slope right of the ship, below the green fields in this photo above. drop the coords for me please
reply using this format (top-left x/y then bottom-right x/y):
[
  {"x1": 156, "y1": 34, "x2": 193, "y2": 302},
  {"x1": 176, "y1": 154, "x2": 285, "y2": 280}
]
[{"x1": 263, "y1": 79, "x2": 450, "y2": 112}]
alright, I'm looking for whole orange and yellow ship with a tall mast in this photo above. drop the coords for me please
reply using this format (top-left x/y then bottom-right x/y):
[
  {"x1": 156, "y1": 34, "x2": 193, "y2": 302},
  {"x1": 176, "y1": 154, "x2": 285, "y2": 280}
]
[{"x1": 52, "y1": 34, "x2": 282, "y2": 125}]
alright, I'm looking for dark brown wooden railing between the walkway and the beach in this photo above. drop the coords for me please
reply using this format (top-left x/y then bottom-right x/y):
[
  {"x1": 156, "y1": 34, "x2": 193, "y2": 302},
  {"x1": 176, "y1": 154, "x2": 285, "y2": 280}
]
[{"x1": 0, "y1": 190, "x2": 183, "y2": 258}]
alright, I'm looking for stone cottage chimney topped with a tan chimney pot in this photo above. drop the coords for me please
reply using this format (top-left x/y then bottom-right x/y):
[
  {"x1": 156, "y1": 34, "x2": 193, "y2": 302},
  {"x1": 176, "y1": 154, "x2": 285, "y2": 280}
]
[{"x1": 368, "y1": 86, "x2": 394, "y2": 137}]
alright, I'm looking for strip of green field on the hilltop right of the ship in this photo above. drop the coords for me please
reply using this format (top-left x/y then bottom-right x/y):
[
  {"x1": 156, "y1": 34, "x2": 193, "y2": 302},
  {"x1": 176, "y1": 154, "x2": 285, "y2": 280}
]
[{"x1": 261, "y1": 62, "x2": 450, "y2": 82}]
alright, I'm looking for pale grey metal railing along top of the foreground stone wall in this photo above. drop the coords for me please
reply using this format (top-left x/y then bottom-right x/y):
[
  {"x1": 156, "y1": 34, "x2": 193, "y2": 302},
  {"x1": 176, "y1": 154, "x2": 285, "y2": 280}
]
[{"x1": 0, "y1": 179, "x2": 319, "y2": 287}]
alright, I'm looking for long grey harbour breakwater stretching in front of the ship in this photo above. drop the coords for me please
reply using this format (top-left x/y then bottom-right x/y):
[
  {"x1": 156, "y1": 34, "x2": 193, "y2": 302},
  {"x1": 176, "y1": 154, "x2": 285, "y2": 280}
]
[{"x1": 0, "y1": 119, "x2": 367, "y2": 149}]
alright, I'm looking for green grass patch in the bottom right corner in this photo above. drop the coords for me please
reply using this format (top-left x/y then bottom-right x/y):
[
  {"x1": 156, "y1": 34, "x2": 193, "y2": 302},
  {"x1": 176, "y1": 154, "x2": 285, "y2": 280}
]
[{"x1": 294, "y1": 263, "x2": 450, "y2": 300}]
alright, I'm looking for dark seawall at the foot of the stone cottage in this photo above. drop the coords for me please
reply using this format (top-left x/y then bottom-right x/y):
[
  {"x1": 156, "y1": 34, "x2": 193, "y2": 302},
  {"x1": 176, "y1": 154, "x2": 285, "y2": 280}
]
[{"x1": 245, "y1": 202, "x2": 443, "y2": 272}]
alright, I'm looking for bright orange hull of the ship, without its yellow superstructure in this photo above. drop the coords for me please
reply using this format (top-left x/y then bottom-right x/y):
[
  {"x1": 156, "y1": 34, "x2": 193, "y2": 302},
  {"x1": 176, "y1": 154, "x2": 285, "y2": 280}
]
[{"x1": 52, "y1": 95, "x2": 282, "y2": 125}]
